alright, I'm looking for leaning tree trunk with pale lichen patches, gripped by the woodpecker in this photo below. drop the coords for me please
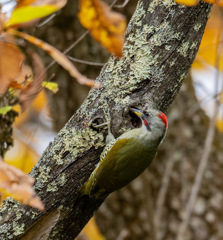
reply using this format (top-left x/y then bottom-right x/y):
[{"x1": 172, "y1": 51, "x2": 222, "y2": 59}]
[{"x1": 0, "y1": 0, "x2": 211, "y2": 240}]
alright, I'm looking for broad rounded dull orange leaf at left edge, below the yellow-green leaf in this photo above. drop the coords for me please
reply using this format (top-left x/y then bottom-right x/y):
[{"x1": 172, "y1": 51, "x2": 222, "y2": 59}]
[{"x1": 0, "y1": 37, "x2": 25, "y2": 95}]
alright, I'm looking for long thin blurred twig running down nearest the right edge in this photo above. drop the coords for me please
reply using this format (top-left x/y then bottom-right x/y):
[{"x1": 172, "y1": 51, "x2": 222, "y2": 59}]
[{"x1": 177, "y1": 28, "x2": 223, "y2": 240}]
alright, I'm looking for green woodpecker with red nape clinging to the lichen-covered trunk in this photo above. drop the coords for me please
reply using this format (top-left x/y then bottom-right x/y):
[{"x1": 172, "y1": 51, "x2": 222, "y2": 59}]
[{"x1": 80, "y1": 108, "x2": 167, "y2": 198}]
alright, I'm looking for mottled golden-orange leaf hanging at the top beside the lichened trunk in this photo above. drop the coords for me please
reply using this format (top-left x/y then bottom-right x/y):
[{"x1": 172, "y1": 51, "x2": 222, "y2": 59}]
[{"x1": 78, "y1": 0, "x2": 126, "y2": 57}]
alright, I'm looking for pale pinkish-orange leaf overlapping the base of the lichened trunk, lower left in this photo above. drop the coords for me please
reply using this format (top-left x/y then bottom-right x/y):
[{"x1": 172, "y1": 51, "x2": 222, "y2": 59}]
[{"x1": 0, "y1": 159, "x2": 44, "y2": 211}]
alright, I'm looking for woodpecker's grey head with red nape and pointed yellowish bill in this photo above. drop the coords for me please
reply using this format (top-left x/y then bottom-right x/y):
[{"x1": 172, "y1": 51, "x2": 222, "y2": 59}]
[{"x1": 130, "y1": 108, "x2": 168, "y2": 134}]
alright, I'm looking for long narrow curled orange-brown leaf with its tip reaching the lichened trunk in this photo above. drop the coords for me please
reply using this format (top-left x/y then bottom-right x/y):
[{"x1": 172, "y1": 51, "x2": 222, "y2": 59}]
[{"x1": 7, "y1": 29, "x2": 101, "y2": 88}]
